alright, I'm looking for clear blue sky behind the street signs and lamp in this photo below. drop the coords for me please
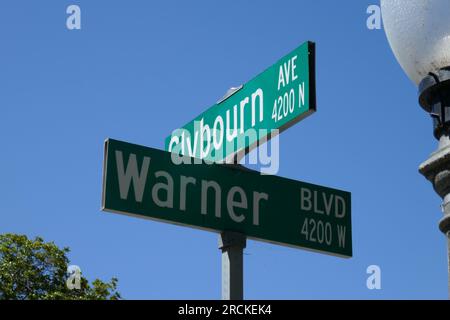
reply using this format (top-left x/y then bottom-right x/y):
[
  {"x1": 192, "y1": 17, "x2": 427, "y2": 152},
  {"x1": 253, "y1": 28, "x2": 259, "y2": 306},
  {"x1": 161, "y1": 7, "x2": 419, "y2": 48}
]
[{"x1": 0, "y1": 0, "x2": 447, "y2": 299}]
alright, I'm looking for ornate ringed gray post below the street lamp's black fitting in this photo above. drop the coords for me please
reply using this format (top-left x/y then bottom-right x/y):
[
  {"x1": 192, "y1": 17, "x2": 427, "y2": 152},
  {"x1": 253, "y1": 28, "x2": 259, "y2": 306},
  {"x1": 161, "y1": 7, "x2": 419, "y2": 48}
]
[{"x1": 419, "y1": 135, "x2": 450, "y2": 298}]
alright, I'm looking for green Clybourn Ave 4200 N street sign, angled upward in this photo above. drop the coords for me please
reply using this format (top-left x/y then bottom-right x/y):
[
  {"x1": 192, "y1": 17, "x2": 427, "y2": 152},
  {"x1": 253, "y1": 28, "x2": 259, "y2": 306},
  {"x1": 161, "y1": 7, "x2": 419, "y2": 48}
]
[{"x1": 165, "y1": 42, "x2": 316, "y2": 162}]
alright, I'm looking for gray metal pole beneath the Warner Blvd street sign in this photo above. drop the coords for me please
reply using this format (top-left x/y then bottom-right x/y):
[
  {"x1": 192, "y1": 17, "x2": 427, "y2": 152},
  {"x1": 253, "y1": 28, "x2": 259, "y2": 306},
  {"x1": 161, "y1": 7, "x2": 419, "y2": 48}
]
[{"x1": 219, "y1": 231, "x2": 247, "y2": 300}]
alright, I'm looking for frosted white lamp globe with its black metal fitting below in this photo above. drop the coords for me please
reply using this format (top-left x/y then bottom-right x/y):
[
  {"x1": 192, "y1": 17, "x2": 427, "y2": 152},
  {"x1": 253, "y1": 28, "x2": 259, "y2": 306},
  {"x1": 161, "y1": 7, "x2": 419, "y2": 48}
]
[{"x1": 381, "y1": 0, "x2": 450, "y2": 139}]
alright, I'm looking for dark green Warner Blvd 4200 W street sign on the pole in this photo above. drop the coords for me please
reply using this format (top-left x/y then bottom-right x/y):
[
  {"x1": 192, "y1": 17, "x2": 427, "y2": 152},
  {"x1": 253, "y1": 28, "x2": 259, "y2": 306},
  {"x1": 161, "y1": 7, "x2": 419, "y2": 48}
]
[{"x1": 102, "y1": 139, "x2": 352, "y2": 257}]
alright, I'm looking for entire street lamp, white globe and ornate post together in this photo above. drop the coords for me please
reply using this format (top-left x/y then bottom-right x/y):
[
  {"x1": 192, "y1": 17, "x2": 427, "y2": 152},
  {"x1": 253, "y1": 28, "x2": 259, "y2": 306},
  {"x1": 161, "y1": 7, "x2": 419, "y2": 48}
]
[{"x1": 381, "y1": 0, "x2": 450, "y2": 297}]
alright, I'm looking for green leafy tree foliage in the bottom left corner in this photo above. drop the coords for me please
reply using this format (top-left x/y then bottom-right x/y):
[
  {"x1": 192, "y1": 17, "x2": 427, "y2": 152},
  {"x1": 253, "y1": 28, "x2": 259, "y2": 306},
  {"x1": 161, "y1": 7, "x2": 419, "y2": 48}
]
[{"x1": 0, "y1": 234, "x2": 121, "y2": 300}]
